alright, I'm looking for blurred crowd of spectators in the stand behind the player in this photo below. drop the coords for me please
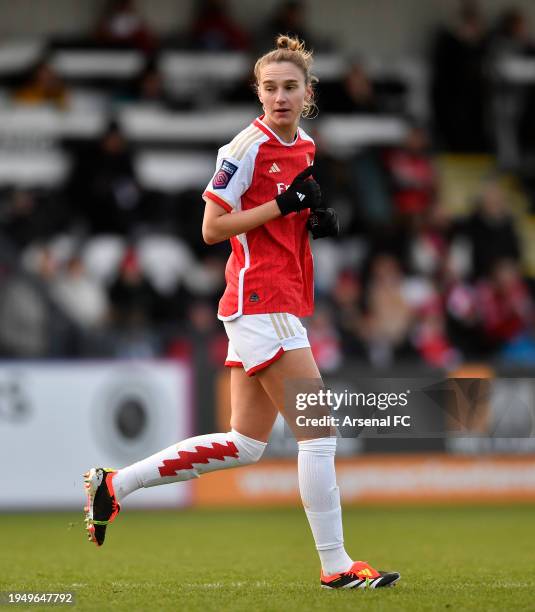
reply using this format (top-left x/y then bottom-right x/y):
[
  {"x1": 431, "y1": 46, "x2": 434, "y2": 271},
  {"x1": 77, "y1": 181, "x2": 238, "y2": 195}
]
[{"x1": 0, "y1": 0, "x2": 535, "y2": 371}]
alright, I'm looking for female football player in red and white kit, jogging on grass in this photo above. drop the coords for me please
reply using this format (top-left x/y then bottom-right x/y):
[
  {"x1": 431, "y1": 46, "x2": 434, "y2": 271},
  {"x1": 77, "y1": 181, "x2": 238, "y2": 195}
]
[{"x1": 85, "y1": 36, "x2": 399, "y2": 588}]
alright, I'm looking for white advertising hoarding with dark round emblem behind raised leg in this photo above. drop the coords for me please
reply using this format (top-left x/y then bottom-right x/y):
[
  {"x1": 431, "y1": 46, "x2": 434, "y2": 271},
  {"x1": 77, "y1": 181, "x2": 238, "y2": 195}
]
[{"x1": 0, "y1": 361, "x2": 191, "y2": 510}]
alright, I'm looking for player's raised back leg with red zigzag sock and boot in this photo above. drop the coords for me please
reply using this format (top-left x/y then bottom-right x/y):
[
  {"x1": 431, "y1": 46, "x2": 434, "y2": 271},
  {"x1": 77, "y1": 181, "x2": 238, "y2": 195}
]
[{"x1": 84, "y1": 368, "x2": 277, "y2": 546}]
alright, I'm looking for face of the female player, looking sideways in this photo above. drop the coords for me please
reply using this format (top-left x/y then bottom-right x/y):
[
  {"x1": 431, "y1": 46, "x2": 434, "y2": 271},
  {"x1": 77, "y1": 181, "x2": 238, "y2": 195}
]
[{"x1": 258, "y1": 62, "x2": 311, "y2": 140}]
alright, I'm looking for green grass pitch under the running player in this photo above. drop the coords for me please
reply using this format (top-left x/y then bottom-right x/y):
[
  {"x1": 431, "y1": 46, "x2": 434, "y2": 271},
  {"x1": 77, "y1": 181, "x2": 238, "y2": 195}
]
[{"x1": 0, "y1": 506, "x2": 535, "y2": 612}]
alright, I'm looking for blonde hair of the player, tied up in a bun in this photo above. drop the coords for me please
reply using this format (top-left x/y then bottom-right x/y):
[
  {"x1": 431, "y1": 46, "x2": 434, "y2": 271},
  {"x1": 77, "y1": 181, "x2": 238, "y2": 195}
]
[{"x1": 254, "y1": 34, "x2": 318, "y2": 117}]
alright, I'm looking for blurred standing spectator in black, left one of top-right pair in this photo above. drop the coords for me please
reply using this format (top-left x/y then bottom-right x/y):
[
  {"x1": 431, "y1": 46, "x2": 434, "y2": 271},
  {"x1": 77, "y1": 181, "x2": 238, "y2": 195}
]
[{"x1": 431, "y1": 0, "x2": 489, "y2": 152}]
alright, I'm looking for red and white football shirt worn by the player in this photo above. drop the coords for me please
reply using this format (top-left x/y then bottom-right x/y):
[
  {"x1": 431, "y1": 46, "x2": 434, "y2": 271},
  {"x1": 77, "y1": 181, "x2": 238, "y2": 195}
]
[{"x1": 203, "y1": 117, "x2": 315, "y2": 321}]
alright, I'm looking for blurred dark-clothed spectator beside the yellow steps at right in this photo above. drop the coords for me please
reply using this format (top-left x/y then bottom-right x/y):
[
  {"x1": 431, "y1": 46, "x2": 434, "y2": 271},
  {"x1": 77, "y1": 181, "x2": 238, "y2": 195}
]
[{"x1": 459, "y1": 180, "x2": 520, "y2": 278}]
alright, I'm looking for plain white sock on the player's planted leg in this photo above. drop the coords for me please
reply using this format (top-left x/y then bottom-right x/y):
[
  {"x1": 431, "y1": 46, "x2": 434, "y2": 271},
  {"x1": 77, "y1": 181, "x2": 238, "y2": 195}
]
[{"x1": 298, "y1": 438, "x2": 353, "y2": 575}]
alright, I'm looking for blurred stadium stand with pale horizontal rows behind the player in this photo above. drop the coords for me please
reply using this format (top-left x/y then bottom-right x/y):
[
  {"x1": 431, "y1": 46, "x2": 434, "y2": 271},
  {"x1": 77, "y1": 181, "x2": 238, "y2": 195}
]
[{"x1": 0, "y1": 3, "x2": 535, "y2": 378}]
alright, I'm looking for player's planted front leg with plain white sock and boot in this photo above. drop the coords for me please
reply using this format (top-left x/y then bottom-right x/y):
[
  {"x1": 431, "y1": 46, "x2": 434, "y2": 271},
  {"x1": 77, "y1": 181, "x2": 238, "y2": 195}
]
[{"x1": 257, "y1": 348, "x2": 399, "y2": 588}]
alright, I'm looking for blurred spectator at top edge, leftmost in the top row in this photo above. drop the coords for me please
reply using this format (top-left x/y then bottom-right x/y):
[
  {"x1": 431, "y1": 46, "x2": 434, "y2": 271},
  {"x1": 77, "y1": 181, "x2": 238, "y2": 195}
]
[{"x1": 95, "y1": 0, "x2": 156, "y2": 53}]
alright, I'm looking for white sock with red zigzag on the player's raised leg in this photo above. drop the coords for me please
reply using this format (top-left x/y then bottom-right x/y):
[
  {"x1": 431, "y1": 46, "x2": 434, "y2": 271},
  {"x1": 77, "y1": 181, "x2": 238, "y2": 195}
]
[{"x1": 113, "y1": 429, "x2": 267, "y2": 501}]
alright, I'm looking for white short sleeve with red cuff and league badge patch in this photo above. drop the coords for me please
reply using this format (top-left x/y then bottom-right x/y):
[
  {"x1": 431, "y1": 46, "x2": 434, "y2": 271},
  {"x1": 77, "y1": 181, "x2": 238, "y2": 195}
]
[{"x1": 203, "y1": 145, "x2": 254, "y2": 212}]
